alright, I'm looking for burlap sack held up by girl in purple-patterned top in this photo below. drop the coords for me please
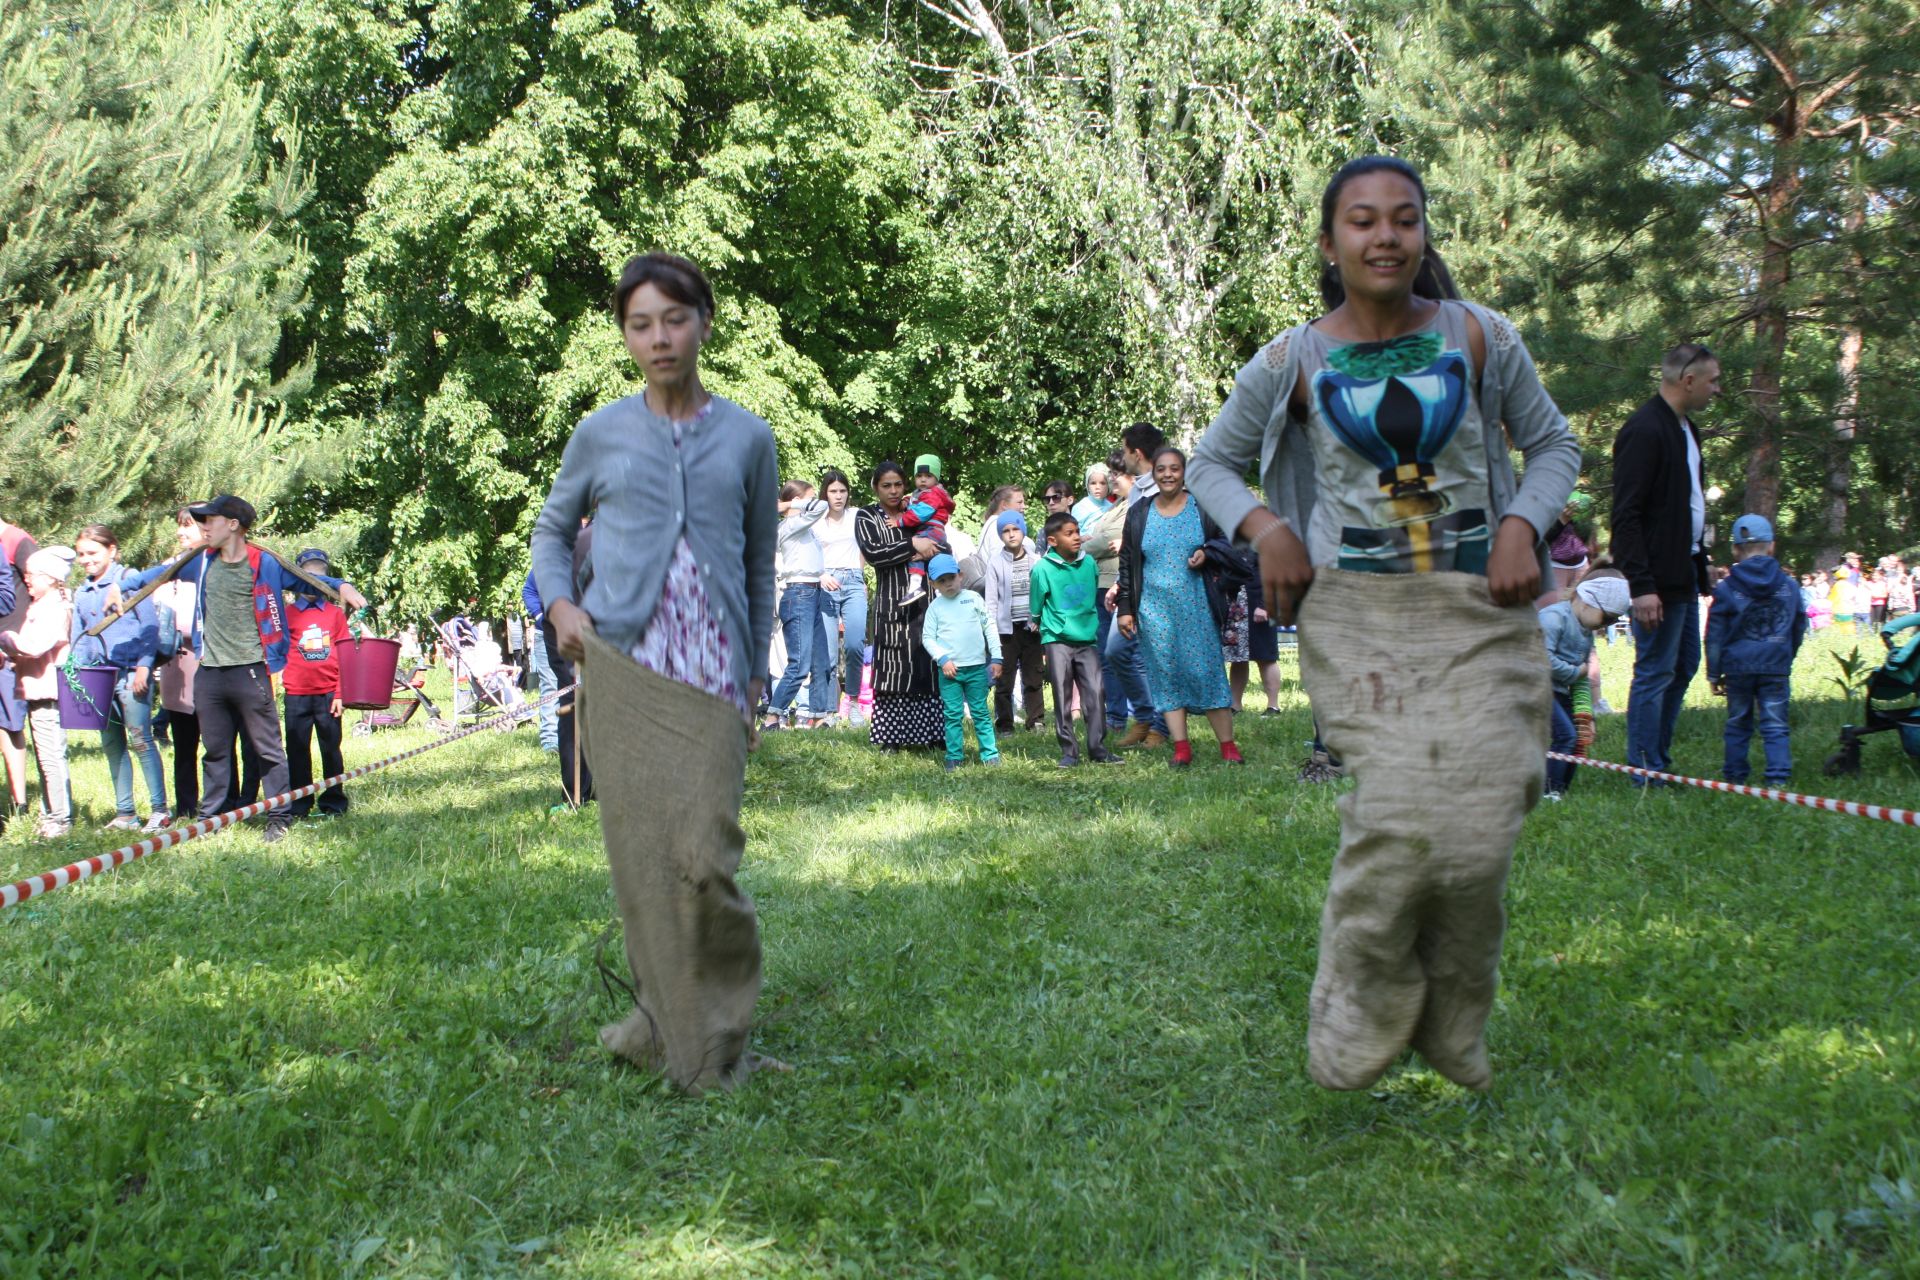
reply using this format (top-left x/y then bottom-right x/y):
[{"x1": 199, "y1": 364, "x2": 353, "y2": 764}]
[{"x1": 576, "y1": 635, "x2": 760, "y2": 1092}]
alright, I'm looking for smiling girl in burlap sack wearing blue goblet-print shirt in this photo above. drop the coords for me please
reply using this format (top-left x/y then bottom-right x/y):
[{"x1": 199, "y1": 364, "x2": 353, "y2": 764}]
[{"x1": 1188, "y1": 155, "x2": 1580, "y2": 1088}]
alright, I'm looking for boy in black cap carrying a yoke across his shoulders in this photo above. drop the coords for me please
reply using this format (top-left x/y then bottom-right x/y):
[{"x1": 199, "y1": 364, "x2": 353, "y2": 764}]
[{"x1": 121, "y1": 493, "x2": 367, "y2": 844}]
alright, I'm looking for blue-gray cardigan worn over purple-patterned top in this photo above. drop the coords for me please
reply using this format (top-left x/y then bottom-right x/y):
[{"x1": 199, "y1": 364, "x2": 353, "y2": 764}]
[{"x1": 534, "y1": 395, "x2": 780, "y2": 691}]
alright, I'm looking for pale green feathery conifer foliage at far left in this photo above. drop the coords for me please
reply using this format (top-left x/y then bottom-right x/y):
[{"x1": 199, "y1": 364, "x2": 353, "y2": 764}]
[{"x1": 0, "y1": 0, "x2": 307, "y2": 555}]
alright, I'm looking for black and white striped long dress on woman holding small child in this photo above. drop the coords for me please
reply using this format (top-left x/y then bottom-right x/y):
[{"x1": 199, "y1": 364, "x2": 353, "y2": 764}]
[{"x1": 852, "y1": 505, "x2": 947, "y2": 747}]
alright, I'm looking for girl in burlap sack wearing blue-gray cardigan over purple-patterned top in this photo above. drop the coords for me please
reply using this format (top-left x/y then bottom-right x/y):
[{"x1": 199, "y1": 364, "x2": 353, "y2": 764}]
[{"x1": 534, "y1": 253, "x2": 780, "y2": 1092}]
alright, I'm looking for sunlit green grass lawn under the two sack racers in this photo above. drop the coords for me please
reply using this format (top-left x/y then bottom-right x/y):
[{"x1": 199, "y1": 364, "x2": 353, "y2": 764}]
[{"x1": 0, "y1": 641, "x2": 1920, "y2": 1276}]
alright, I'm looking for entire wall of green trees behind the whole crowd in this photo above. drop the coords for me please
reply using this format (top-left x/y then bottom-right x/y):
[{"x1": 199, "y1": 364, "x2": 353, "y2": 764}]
[{"x1": 11, "y1": 0, "x2": 1920, "y2": 616}]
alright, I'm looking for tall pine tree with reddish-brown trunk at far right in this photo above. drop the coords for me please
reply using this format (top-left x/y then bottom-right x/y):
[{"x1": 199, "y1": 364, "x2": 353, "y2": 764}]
[{"x1": 1386, "y1": 0, "x2": 1920, "y2": 560}]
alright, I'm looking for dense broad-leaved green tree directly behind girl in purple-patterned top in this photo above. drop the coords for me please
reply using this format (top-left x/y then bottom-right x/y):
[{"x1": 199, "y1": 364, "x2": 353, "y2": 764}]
[{"x1": 299, "y1": 0, "x2": 912, "y2": 610}]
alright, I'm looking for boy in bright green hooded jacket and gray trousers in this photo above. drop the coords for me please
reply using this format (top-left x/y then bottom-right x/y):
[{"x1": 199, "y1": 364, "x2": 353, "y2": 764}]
[{"x1": 1029, "y1": 510, "x2": 1119, "y2": 770}]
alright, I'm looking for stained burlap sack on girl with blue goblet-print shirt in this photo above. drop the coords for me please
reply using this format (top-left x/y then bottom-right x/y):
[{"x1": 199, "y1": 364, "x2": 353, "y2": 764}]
[{"x1": 1300, "y1": 570, "x2": 1551, "y2": 1088}]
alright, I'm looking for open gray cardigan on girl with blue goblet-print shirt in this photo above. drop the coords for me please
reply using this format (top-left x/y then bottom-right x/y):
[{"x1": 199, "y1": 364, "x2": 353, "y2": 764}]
[{"x1": 1187, "y1": 301, "x2": 1580, "y2": 583}]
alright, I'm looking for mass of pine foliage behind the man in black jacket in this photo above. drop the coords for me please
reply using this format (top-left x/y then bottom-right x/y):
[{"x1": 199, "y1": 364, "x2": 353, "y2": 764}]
[{"x1": 1373, "y1": 0, "x2": 1920, "y2": 557}]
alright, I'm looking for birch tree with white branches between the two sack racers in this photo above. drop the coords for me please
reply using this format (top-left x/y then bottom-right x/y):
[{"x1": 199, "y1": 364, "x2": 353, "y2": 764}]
[{"x1": 895, "y1": 0, "x2": 1359, "y2": 450}]
